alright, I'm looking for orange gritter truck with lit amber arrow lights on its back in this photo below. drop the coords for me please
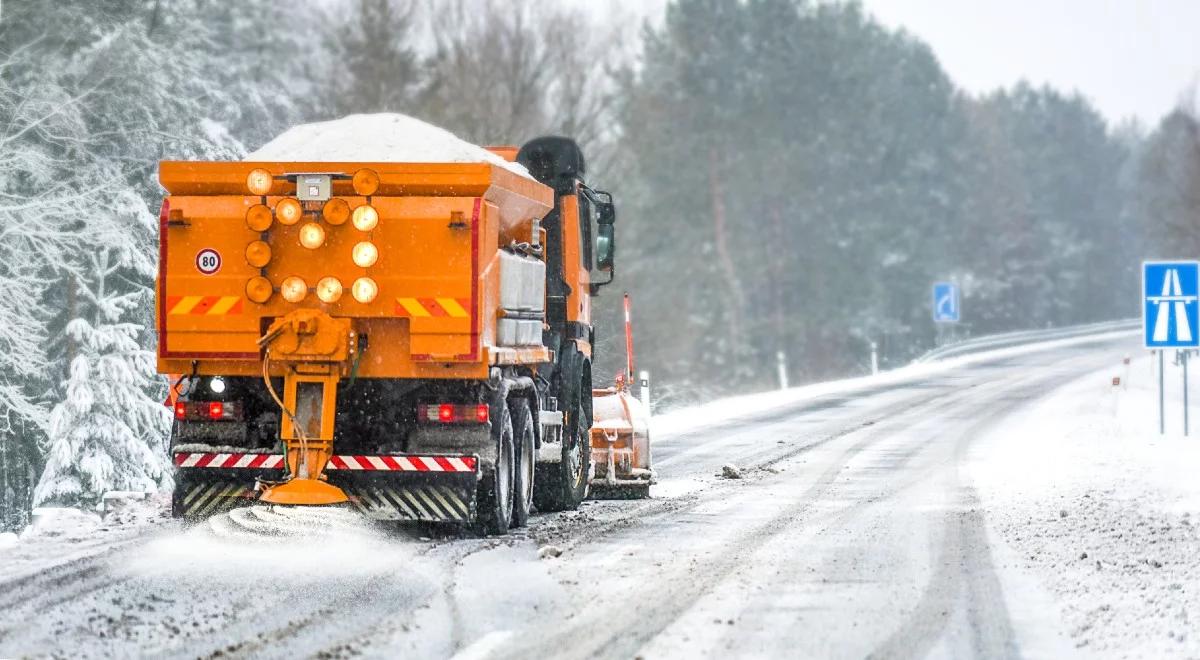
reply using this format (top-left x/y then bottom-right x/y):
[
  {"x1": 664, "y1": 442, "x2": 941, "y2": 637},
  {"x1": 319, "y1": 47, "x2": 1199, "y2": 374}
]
[{"x1": 156, "y1": 137, "x2": 616, "y2": 534}]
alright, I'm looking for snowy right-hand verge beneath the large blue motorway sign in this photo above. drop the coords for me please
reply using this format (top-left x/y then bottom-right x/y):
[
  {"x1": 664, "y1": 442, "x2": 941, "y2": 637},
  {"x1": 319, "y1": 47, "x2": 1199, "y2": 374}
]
[{"x1": 970, "y1": 358, "x2": 1200, "y2": 658}]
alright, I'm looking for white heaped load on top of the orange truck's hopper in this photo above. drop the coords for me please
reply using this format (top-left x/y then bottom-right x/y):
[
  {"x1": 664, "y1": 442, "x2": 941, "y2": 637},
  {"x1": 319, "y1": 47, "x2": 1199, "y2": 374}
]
[{"x1": 245, "y1": 113, "x2": 529, "y2": 176}]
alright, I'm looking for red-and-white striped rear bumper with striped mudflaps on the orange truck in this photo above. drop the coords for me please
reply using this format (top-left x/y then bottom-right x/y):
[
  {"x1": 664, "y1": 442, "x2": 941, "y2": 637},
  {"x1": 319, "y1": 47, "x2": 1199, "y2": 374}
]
[{"x1": 174, "y1": 452, "x2": 480, "y2": 523}]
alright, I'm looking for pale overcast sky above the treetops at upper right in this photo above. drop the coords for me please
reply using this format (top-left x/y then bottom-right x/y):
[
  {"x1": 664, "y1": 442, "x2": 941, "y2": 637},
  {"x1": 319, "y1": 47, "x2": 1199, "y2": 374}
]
[{"x1": 604, "y1": 0, "x2": 1200, "y2": 125}]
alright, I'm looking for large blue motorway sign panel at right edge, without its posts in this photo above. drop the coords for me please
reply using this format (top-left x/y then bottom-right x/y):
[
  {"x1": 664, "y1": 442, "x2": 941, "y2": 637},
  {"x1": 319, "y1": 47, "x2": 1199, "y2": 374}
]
[{"x1": 1141, "y1": 262, "x2": 1200, "y2": 348}]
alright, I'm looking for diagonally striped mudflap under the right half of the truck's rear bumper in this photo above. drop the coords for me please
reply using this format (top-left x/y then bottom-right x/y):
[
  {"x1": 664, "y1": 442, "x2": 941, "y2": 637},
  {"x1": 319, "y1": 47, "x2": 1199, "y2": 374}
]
[{"x1": 342, "y1": 484, "x2": 472, "y2": 522}]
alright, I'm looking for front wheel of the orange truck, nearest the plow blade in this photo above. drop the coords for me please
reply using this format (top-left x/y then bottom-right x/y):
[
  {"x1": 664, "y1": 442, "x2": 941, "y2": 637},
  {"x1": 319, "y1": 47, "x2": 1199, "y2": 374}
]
[{"x1": 534, "y1": 376, "x2": 592, "y2": 511}]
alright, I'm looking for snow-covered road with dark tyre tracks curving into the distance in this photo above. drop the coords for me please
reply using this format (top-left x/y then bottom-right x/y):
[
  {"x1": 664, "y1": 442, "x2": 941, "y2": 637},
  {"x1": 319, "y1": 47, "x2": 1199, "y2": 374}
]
[{"x1": 7, "y1": 336, "x2": 1200, "y2": 658}]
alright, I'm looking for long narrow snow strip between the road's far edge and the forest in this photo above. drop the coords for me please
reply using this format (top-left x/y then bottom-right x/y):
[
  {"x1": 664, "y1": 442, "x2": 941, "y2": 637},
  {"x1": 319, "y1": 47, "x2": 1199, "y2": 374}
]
[{"x1": 650, "y1": 330, "x2": 1138, "y2": 437}]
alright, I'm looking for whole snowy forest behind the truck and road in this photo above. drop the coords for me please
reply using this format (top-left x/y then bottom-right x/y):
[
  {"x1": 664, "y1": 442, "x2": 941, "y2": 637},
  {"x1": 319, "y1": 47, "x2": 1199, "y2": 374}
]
[{"x1": 0, "y1": 0, "x2": 1200, "y2": 530}]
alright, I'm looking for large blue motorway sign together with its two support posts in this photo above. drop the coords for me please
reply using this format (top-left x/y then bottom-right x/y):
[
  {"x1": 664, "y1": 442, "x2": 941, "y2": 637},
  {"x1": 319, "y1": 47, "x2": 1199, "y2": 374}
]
[{"x1": 1141, "y1": 262, "x2": 1200, "y2": 436}]
